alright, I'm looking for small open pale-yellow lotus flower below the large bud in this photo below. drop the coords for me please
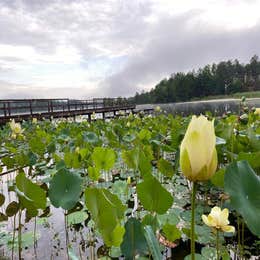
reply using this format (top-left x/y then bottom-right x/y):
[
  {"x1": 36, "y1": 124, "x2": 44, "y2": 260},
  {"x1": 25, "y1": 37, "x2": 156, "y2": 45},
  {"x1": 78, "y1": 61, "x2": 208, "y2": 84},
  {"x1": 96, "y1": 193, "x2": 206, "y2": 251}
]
[{"x1": 202, "y1": 207, "x2": 235, "y2": 233}]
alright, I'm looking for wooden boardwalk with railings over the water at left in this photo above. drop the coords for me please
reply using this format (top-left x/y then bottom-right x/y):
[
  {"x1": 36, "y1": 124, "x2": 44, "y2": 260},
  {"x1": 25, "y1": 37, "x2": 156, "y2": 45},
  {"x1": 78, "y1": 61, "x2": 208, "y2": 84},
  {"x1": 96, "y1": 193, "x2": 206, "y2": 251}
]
[{"x1": 0, "y1": 98, "x2": 135, "y2": 124}]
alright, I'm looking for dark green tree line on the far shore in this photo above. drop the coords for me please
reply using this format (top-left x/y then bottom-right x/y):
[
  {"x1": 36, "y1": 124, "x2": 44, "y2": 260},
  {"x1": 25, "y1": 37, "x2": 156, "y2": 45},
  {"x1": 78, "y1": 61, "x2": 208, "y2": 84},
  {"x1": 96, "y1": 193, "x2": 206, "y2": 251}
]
[{"x1": 130, "y1": 55, "x2": 260, "y2": 104}]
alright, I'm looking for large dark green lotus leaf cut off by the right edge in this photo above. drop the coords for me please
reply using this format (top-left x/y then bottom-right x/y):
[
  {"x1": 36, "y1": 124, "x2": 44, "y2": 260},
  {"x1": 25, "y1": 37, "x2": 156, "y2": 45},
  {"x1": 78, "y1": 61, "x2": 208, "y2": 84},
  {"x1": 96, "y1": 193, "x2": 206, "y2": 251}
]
[{"x1": 225, "y1": 161, "x2": 260, "y2": 237}]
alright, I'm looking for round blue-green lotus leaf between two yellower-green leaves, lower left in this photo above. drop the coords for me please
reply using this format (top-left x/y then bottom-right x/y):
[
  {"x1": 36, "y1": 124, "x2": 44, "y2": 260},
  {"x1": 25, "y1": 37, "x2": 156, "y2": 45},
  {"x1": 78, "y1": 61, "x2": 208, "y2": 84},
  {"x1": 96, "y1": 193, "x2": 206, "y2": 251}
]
[{"x1": 49, "y1": 168, "x2": 82, "y2": 210}]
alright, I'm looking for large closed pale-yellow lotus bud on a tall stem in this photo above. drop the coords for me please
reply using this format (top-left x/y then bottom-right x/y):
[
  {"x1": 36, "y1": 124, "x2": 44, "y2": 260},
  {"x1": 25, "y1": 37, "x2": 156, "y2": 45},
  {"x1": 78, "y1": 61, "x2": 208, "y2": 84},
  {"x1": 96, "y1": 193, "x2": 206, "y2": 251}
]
[{"x1": 180, "y1": 115, "x2": 217, "y2": 182}]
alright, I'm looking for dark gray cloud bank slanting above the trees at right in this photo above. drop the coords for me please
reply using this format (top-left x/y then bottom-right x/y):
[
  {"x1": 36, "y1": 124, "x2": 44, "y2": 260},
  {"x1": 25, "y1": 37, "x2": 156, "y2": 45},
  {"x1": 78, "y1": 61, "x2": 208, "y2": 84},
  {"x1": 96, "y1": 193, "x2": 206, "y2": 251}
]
[{"x1": 102, "y1": 12, "x2": 260, "y2": 96}]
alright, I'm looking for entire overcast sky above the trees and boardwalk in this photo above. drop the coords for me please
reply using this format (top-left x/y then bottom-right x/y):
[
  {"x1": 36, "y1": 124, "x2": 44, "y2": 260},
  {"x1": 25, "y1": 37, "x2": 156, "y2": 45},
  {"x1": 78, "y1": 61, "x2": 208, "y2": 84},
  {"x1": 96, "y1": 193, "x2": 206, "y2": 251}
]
[{"x1": 0, "y1": 0, "x2": 260, "y2": 98}]
